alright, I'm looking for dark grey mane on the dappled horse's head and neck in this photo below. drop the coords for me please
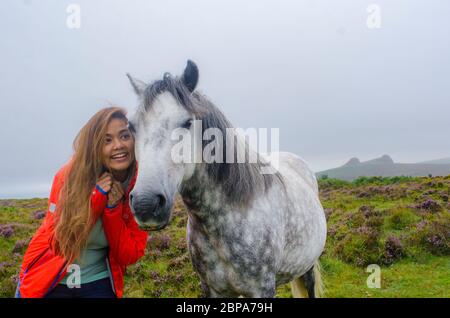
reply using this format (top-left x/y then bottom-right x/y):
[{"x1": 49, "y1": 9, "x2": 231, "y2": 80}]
[{"x1": 142, "y1": 73, "x2": 283, "y2": 206}]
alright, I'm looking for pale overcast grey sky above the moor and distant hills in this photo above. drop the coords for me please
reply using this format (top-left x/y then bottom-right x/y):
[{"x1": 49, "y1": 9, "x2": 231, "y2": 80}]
[{"x1": 0, "y1": 0, "x2": 450, "y2": 198}]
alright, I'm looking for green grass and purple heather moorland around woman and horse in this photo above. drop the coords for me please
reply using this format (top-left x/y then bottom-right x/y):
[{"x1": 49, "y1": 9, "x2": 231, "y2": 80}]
[{"x1": 0, "y1": 176, "x2": 450, "y2": 298}]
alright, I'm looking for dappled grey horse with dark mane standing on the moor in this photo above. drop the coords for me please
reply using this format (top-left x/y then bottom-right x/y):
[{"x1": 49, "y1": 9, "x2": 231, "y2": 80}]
[{"x1": 127, "y1": 61, "x2": 327, "y2": 298}]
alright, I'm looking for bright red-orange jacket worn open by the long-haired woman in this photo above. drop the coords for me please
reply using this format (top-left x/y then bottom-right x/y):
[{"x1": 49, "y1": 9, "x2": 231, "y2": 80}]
[{"x1": 16, "y1": 163, "x2": 148, "y2": 298}]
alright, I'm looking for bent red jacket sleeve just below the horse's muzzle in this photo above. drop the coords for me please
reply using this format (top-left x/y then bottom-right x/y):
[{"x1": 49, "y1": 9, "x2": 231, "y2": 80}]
[{"x1": 102, "y1": 200, "x2": 148, "y2": 266}]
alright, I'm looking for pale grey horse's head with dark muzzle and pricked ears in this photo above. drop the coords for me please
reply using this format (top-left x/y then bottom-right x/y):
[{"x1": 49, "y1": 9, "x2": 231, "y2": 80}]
[{"x1": 127, "y1": 61, "x2": 199, "y2": 229}]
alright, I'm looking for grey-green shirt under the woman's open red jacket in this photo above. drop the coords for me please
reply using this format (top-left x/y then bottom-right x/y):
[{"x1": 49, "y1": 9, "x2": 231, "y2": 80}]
[{"x1": 60, "y1": 218, "x2": 110, "y2": 285}]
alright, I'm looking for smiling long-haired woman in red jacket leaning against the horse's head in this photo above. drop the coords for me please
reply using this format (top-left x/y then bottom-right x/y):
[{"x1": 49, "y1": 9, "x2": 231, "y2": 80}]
[{"x1": 16, "y1": 107, "x2": 147, "y2": 298}]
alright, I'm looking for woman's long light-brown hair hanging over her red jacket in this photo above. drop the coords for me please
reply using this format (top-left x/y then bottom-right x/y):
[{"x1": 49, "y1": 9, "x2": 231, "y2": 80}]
[{"x1": 52, "y1": 107, "x2": 132, "y2": 262}]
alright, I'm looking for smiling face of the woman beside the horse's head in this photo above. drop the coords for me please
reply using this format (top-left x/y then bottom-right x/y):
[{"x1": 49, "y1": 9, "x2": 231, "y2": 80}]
[{"x1": 103, "y1": 118, "x2": 134, "y2": 172}]
